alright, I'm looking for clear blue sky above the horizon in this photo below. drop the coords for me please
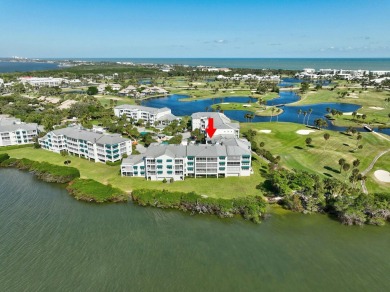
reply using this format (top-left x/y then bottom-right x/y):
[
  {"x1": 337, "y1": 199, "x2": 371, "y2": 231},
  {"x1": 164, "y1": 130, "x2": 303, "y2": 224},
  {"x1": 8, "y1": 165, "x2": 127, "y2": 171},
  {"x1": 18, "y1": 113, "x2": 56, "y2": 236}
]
[{"x1": 0, "y1": 0, "x2": 390, "y2": 58}]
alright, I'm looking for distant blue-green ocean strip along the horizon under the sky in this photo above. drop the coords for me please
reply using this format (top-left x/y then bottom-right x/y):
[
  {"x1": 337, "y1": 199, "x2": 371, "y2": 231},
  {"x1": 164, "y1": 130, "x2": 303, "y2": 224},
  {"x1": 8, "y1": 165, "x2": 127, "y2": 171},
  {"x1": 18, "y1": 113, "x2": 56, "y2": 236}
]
[{"x1": 52, "y1": 58, "x2": 390, "y2": 70}]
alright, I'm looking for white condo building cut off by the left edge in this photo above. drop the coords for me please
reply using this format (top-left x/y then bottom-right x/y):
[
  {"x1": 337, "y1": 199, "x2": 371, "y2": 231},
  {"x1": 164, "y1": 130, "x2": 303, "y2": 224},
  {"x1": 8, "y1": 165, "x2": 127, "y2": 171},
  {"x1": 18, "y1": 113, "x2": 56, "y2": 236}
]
[{"x1": 0, "y1": 115, "x2": 39, "y2": 146}]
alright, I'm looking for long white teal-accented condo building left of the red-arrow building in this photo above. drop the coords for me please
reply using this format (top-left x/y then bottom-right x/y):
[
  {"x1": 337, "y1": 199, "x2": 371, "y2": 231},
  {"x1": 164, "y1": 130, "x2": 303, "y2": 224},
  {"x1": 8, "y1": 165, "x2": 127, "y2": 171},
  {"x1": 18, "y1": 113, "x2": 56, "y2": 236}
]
[{"x1": 38, "y1": 127, "x2": 132, "y2": 163}]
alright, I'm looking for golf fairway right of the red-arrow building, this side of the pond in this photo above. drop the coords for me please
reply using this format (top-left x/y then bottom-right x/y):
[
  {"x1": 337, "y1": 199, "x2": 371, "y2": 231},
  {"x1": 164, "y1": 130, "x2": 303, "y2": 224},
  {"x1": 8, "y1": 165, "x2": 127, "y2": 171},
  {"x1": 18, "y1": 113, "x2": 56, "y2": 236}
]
[{"x1": 241, "y1": 122, "x2": 390, "y2": 192}]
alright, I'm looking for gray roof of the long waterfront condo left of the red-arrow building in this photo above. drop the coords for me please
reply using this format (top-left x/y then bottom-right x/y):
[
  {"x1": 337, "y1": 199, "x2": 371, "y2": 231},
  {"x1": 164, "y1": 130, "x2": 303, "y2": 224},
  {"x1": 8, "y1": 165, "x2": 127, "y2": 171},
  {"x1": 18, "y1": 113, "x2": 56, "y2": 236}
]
[{"x1": 52, "y1": 127, "x2": 129, "y2": 145}]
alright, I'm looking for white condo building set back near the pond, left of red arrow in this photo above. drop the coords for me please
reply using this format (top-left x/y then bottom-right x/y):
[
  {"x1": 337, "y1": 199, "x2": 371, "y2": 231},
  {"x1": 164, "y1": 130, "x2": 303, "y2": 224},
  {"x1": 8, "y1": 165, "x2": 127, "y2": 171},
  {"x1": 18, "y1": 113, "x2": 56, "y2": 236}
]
[{"x1": 114, "y1": 104, "x2": 179, "y2": 125}]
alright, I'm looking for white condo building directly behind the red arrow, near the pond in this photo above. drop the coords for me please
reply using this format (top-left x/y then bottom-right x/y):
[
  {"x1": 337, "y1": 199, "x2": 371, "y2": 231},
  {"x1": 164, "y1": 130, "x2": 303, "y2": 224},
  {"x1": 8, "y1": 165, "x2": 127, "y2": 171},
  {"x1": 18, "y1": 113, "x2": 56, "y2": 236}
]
[{"x1": 191, "y1": 112, "x2": 240, "y2": 138}]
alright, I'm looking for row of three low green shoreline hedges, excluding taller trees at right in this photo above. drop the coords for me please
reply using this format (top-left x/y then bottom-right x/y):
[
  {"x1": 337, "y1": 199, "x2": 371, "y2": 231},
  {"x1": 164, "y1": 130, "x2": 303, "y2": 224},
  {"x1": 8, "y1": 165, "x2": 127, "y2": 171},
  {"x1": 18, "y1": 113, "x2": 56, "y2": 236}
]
[{"x1": 0, "y1": 153, "x2": 267, "y2": 223}]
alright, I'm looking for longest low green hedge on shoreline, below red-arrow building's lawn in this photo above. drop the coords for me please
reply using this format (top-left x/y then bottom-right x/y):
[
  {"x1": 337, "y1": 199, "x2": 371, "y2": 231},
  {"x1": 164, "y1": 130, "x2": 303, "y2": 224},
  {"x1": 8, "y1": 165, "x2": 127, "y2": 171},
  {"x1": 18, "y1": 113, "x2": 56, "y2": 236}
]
[{"x1": 132, "y1": 189, "x2": 267, "y2": 223}]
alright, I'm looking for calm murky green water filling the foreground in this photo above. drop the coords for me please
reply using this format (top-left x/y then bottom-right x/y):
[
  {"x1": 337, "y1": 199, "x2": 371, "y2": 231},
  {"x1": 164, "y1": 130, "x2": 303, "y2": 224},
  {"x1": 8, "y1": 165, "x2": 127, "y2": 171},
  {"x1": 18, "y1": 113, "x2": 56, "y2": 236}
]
[{"x1": 0, "y1": 169, "x2": 390, "y2": 291}]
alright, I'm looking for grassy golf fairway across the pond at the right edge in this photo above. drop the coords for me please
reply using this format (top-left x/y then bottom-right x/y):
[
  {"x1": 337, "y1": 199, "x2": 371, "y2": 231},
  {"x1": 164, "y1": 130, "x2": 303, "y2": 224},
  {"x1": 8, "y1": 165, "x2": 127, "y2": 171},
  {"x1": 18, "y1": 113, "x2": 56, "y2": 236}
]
[{"x1": 291, "y1": 89, "x2": 390, "y2": 127}]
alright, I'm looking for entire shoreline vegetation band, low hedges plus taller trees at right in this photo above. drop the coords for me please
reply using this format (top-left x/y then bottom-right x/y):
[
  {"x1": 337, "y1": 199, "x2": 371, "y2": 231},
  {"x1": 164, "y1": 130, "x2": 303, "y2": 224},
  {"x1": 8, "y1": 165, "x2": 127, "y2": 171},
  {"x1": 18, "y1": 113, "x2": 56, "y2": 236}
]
[{"x1": 0, "y1": 153, "x2": 390, "y2": 226}]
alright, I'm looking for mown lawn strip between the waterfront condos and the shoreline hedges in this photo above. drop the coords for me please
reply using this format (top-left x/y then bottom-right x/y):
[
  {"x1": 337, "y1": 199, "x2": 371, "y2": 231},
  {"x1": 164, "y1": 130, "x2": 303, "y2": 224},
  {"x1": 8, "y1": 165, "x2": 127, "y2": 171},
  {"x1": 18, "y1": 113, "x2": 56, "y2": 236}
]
[{"x1": 0, "y1": 148, "x2": 264, "y2": 198}]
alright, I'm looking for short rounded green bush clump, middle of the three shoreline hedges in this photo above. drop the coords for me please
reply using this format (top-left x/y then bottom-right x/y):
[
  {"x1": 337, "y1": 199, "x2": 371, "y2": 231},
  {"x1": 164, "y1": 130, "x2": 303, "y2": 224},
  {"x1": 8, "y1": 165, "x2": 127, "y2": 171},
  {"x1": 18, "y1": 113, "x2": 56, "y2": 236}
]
[{"x1": 66, "y1": 178, "x2": 129, "y2": 203}]
